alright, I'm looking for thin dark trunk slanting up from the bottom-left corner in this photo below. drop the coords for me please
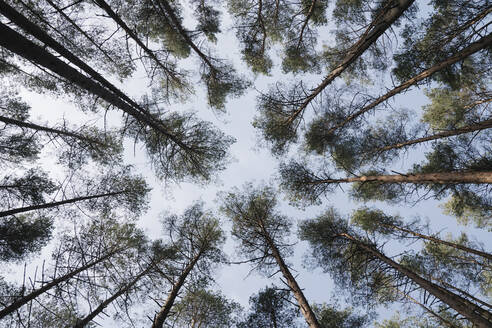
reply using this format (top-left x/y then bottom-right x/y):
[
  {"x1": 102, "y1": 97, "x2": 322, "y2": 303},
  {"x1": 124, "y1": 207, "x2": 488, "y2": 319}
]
[{"x1": 0, "y1": 248, "x2": 123, "y2": 319}]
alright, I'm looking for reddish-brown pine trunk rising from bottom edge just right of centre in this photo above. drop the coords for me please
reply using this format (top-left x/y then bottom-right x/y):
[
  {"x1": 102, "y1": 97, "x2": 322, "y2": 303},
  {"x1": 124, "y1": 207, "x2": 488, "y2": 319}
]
[{"x1": 262, "y1": 231, "x2": 322, "y2": 328}]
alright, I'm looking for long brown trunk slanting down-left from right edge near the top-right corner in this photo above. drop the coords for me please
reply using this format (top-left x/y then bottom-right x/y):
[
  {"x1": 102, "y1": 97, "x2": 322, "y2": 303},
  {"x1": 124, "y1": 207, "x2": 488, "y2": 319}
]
[{"x1": 327, "y1": 33, "x2": 492, "y2": 134}]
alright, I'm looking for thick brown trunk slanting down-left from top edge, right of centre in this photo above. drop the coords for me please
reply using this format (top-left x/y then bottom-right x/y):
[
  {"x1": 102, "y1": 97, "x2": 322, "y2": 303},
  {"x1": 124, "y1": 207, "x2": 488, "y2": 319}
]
[{"x1": 287, "y1": 0, "x2": 415, "y2": 124}]
